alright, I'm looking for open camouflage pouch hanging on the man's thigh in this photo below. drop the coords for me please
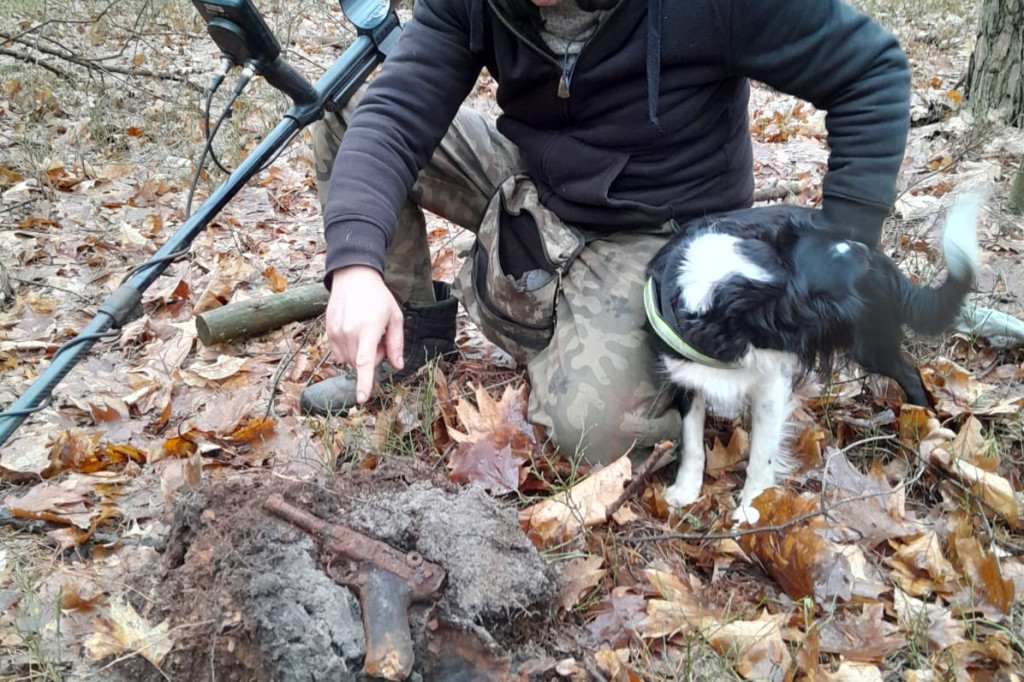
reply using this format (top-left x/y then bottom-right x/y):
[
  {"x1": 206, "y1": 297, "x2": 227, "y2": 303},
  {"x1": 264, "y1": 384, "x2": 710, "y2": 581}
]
[{"x1": 456, "y1": 175, "x2": 585, "y2": 363}]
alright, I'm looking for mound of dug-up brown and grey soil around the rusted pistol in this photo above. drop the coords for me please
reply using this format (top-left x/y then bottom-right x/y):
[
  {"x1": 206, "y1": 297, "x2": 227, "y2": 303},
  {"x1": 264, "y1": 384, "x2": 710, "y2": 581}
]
[{"x1": 121, "y1": 470, "x2": 557, "y2": 682}]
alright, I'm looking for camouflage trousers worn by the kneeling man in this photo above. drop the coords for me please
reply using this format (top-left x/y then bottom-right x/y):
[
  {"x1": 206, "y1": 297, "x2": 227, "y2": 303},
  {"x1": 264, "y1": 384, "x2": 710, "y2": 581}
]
[{"x1": 312, "y1": 87, "x2": 681, "y2": 464}]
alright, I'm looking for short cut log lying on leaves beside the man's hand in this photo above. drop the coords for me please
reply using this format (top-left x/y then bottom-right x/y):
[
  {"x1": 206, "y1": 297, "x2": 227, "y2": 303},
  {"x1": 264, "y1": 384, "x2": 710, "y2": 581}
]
[{"x1": 196, "y1": 284, "x2": 328, "y2": 346}]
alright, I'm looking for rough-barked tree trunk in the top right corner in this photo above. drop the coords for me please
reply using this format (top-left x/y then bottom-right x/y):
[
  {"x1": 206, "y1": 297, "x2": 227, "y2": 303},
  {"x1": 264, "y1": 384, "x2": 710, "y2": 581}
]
[{"x1": 966, "y1": 0, "x2": 1024, "y2": 126}]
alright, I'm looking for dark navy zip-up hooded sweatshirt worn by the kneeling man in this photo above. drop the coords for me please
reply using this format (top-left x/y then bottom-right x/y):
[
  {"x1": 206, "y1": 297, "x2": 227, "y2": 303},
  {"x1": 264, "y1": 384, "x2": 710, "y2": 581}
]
[{"x1": 324, "y1": 0, "x2": 909, "y2": 281}]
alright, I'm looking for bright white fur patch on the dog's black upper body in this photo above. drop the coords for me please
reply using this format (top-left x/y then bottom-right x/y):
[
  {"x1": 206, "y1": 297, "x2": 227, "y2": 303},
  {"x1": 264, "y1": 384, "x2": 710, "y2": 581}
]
[{"x1": 678, "y1": 232, "x2": 772, "y2": 315}]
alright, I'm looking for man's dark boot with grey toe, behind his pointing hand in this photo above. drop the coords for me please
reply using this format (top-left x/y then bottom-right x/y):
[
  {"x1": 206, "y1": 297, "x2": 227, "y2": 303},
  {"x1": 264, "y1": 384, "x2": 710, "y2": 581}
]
[{"x1": 299, "y1": 282, "x2": 459, "y2": 415}]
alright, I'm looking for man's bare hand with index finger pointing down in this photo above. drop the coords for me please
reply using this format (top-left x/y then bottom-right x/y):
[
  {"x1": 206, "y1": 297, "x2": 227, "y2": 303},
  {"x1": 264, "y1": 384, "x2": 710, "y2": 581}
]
[{"x1": 327, "y1": 265, "x2": 404, "y2": 403}]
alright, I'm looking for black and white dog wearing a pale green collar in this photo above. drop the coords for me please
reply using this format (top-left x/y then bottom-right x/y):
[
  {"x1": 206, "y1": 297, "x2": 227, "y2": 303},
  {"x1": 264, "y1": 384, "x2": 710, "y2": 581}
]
[{"x1": 644, "y1": 197, "x2": 981, "y2": 522}]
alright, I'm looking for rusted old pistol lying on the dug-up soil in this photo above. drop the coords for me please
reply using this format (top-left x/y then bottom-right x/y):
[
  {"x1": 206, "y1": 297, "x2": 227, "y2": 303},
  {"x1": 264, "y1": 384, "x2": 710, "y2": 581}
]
[{"x1": 263, "y1": 494, "x2": 444, "y2": 680}]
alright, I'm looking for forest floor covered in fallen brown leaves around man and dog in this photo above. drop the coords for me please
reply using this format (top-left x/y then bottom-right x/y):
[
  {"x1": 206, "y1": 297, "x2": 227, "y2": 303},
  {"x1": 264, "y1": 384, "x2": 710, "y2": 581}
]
[{"x1": 0, "y1": 0, "x2": 1024, "y2": 682}]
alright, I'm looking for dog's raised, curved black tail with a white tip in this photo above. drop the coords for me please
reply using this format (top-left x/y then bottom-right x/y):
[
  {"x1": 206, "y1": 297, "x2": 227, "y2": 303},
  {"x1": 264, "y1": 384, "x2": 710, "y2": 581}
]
[{"x1": 901, "y1": 194, "x2": 982, "y2": 335}]
